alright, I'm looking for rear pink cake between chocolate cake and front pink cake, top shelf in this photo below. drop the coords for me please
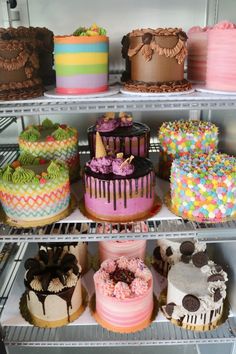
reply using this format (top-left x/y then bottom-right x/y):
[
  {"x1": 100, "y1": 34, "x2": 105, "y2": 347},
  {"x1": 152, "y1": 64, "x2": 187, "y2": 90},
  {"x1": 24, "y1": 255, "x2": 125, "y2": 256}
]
[{"x1": 187, "y1": 26, "x2": 212, "y2": 83}]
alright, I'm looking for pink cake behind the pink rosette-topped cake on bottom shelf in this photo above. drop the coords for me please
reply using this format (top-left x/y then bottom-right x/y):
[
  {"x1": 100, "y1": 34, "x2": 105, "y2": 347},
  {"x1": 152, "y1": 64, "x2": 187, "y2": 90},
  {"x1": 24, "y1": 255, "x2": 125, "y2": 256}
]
[{"x1": 97, "y1": 221, "x2": 148, "y2": 262}]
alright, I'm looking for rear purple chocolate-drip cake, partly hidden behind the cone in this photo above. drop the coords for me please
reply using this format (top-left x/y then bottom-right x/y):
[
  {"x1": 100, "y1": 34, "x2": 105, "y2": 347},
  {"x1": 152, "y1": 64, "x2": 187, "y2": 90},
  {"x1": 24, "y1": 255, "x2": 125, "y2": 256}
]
[{"x1": 88, "y1": 112, "x2": 150, "y2": 158}]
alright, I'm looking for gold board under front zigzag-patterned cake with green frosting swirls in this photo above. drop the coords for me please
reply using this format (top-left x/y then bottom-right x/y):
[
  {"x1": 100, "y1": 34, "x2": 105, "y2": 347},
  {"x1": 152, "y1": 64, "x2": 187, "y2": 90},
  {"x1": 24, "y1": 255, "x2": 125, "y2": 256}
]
[{"x1": 0, "y1": 194, "x2": 77, "y2": 228}]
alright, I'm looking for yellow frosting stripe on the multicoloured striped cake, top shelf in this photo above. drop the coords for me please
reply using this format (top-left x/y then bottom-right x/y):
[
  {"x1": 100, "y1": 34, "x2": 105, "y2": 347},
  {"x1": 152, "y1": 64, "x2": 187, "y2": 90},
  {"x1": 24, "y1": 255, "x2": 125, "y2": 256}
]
[{"x1": 55, "y1": 53, "x2": 108, "y2": 65}]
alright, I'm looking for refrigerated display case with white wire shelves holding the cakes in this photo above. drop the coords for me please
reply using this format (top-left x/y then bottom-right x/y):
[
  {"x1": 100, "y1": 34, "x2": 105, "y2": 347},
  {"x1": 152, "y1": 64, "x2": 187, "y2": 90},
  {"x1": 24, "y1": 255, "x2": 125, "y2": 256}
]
[{"x1": 0, "y1": 0, "x2": 236, "y2": 354}]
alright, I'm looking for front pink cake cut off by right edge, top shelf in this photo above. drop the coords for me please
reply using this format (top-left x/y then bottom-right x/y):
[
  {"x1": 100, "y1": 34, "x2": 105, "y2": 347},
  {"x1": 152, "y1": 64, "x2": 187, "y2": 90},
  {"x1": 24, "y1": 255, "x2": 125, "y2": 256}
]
[{"x1": 206, "y1": 21, "x2": 236, "y2": 91}]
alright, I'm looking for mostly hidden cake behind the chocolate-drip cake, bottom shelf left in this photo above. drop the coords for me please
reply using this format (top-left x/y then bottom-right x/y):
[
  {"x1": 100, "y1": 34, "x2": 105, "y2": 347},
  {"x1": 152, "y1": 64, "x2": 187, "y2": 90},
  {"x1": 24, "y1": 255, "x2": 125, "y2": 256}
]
[{"x1": 38, "y1": 242, "x2": 88, "y2": 274}]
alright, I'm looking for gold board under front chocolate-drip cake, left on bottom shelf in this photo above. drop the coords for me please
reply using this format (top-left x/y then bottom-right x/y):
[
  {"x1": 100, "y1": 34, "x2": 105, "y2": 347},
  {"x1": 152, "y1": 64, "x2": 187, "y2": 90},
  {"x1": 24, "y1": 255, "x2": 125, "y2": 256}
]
[{"x1": 19, "y1": 286, "x2": 88, "y2": 328}]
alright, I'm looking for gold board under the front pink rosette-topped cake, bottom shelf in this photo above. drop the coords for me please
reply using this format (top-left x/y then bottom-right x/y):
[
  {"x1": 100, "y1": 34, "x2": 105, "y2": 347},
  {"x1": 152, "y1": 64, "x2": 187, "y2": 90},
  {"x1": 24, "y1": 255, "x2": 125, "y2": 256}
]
[{"x1": 89, "y1": 293, "x2": 158, "y2": 333}]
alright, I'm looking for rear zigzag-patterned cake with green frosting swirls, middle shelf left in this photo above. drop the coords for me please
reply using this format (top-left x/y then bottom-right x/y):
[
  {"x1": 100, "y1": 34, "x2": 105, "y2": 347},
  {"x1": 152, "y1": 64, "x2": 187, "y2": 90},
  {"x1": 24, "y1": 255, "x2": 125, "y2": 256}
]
[{"x1": 19, "y1": 119, "x2": 80, "y2": 180}]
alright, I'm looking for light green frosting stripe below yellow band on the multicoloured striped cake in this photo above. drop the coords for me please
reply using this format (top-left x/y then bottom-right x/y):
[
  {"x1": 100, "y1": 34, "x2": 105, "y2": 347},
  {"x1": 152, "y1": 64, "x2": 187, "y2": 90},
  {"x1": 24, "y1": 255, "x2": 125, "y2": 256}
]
[{"x1": 55, "y1": 64, "x2": 107, "y2": 76}]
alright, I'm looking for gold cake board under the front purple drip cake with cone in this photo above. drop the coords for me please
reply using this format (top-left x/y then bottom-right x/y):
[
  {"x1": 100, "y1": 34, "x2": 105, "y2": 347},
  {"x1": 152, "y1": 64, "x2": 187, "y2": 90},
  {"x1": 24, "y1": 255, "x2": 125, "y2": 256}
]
[{"x1": 79, "y1": 195, "x2": 162, "y2": 223}]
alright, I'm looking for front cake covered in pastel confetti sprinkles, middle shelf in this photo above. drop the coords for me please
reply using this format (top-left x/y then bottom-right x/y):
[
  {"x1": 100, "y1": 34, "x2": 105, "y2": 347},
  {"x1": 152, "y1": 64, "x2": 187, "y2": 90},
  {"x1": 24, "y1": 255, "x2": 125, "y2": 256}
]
[{"x1": 171, "y1": 153, "x2": 236, "y2": 222}]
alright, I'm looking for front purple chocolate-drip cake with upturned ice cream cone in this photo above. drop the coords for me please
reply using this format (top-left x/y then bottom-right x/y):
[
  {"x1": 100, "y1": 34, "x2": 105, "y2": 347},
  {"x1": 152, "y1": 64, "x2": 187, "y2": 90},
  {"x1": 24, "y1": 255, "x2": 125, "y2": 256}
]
[{"x1": 84, "y1": 132, "x2": 155, "y2": 222}]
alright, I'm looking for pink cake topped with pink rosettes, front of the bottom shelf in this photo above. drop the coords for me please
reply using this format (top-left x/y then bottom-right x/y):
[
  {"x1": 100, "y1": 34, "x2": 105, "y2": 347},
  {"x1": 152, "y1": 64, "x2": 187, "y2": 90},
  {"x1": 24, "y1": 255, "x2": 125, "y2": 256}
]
[{"x1": 94, "y1": 257, "x2": 153, "y2": 333}]
